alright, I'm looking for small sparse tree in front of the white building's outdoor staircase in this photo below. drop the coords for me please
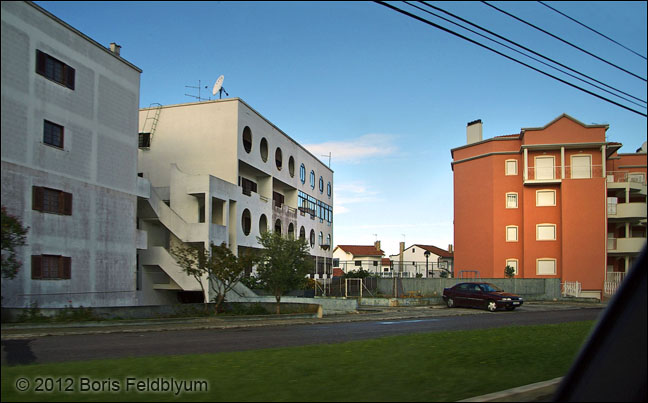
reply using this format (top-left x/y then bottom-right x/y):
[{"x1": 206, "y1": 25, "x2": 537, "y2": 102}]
[{"x1": 171, "y1": 243, "x2": 256, "y2": 313}]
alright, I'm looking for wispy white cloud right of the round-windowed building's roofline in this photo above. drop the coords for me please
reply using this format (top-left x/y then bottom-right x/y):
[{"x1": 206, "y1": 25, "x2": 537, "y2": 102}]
[{"x1": 304, "y1": 134, "x2": 396, "y2": 163}]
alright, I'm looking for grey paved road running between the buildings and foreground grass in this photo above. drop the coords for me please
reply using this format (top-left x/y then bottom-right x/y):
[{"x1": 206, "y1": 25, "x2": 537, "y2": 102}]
[{"x1": 2, "y1": 306, "x2": 602, "y2": 365}]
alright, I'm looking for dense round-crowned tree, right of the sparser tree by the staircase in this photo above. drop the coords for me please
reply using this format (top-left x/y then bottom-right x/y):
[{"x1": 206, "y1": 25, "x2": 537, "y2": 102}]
[{"x1": 257, "y1": 231, "x2": 313, "y2": 314}]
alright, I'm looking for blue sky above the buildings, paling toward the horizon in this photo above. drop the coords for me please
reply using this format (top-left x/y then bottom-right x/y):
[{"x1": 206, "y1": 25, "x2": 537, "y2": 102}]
[{"x1": 36, "y1": 1, "x2": 647, "y2": 254}]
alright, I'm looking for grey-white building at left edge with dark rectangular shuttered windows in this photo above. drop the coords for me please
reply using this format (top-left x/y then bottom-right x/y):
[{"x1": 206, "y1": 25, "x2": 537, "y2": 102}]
[{"x1": 2, "y1": 1, "x2": 141, "y2": 307}]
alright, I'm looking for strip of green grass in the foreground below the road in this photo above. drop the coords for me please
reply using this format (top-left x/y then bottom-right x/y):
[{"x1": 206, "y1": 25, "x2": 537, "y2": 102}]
[{"x1": 2, "y1": 321, "x2": 595, "y2": 402}]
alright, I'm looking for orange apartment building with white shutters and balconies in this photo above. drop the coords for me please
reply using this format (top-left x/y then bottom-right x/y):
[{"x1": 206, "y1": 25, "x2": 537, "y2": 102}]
[{"x1": 451, "y1": 114, "x2": 646, "y2": 298}]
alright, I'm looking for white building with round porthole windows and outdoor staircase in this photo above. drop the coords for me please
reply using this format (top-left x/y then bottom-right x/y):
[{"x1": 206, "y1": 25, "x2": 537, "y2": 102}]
[{"x1": 138, "y1": 98, "x2": 333, "y2": 303}]
